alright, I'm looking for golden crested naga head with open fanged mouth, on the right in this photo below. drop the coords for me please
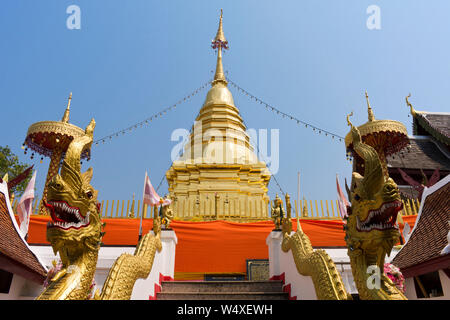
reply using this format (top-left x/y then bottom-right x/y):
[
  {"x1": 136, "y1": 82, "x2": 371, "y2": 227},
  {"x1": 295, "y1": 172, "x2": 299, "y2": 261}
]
[{"x1": 345, "y1": 122, "x2": 403, "y2": 267}]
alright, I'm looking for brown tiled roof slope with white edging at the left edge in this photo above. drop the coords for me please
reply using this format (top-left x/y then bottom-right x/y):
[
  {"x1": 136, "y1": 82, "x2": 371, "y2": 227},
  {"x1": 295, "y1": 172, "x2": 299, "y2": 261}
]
[{"x1": 0, "y1": 183, "x2": 47, "y2": 283}]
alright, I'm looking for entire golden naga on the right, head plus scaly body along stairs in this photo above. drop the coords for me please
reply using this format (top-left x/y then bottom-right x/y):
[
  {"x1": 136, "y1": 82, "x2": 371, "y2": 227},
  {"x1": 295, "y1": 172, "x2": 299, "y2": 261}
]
[{"x1": 282, "y1": 121, "x2": 407, "y2": 300}]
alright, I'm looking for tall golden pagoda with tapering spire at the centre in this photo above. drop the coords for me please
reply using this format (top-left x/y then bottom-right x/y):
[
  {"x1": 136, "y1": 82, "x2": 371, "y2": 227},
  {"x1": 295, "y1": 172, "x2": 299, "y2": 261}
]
[{"x1": 166, "y1": 12, "x2": 270, "y2": 221}]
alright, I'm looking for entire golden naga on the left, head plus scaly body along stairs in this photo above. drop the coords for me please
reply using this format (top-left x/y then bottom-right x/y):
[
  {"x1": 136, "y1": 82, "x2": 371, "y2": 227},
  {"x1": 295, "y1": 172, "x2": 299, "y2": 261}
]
[{"x1": 36, "y1": 119, "x2": 162, "y2": 300}]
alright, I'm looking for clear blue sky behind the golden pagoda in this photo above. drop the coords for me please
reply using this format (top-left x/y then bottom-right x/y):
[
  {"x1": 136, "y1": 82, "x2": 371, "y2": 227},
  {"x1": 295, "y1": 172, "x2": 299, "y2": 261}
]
[{"x1": 0, "y1": 0, "x2": 450, "y2": 204}]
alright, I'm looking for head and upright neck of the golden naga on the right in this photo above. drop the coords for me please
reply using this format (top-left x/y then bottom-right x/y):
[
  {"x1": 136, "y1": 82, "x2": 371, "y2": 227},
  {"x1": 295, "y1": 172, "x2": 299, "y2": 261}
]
[{"x1": 344, "y1": 121, "x2": 407, "y2": 300}]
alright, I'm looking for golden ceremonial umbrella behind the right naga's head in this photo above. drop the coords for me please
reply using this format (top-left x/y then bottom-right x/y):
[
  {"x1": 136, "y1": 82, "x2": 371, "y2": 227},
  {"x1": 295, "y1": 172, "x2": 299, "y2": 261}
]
[{"x1": 345, "y1": 91, "x2": 409, "y2": 176}]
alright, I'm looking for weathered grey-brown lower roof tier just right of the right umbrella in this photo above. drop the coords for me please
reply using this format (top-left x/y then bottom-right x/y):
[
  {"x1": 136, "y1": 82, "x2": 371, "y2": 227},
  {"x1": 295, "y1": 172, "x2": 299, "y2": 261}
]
[{"x1": 386, "y1": 136, "x2": 450, "y2": 171}]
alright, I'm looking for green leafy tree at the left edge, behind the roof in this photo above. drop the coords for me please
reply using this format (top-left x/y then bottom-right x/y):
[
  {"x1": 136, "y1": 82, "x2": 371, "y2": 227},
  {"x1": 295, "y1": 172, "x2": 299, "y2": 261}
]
[{"x1": 0, "y1": 146, "x2": 31, "y2": 197}]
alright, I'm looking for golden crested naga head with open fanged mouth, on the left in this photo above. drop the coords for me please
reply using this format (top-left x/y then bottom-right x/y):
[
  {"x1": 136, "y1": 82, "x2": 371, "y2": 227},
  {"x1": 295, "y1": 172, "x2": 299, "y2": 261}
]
[{"x1": 45, "y1": 119, "x2": 102, "y2": 258}]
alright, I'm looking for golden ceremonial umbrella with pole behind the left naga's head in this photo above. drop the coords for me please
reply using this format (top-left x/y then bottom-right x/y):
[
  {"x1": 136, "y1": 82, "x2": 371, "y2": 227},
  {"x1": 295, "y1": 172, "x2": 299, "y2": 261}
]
[{"x1": 23, "y1": 93, "x2": 91, "y2": 214}]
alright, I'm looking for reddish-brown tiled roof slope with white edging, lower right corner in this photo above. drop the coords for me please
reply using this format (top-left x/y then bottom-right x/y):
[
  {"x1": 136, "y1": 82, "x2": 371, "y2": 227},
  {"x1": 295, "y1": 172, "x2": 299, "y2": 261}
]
[{"x1": 392, "y1": 176, "x2": 450, "y2": 276}]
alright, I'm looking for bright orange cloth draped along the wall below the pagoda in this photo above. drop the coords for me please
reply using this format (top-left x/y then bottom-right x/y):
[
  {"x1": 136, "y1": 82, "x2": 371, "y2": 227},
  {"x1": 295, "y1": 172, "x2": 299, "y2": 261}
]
[{"x1": 22, "y1": 216, "x2": 417, "y2": 281}]
